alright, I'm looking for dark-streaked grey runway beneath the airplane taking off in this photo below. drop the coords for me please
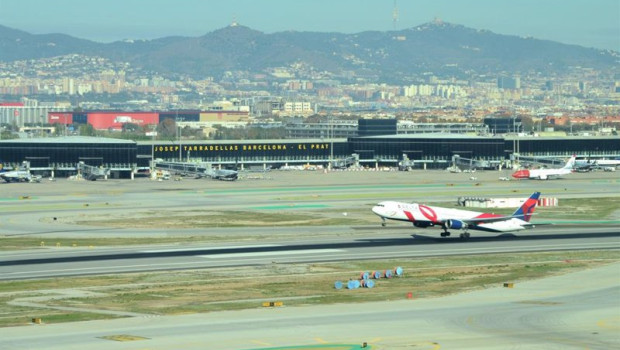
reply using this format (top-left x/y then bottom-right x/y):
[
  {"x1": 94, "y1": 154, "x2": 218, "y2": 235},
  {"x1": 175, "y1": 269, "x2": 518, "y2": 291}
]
[{"x1": 0, "y1": 227, "x2": 620, "y2": 280}]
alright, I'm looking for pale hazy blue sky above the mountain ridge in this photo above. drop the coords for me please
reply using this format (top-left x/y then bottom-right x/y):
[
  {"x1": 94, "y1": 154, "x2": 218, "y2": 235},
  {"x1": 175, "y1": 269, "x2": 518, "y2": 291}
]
[{"x1": 0, "y1": 0, "x2": 620, "y2": 51}]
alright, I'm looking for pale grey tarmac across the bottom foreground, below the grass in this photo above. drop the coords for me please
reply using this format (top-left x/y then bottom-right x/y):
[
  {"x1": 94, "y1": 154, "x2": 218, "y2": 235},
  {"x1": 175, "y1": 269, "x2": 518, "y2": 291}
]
[{"x1": 0, "y1": 263, "x2": 620, "y2": 350}]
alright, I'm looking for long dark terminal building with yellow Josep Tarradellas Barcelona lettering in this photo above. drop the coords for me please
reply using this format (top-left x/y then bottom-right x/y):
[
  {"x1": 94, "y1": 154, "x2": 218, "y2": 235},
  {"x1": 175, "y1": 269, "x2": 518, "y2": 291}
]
[{"x1": 0, "y1": 134, "x2": 620, "y2": 178}]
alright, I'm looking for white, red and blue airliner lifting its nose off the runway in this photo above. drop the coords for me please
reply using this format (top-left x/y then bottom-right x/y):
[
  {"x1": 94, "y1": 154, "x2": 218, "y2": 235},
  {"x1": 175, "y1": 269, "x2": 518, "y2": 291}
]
[{"x1": 372, "y1": 192, "x2": 540, "y2": 238}]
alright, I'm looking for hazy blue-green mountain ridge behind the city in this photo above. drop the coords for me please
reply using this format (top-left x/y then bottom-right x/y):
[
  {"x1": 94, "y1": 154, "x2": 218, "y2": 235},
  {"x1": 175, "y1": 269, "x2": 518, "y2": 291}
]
[{"x1": 0, "y1": 21, "x2": 620, "y2": 82}]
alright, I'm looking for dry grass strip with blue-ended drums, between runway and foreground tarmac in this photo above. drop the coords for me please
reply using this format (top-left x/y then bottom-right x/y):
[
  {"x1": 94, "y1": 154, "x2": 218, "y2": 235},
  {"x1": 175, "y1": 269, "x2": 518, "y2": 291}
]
[{"x1": 0, "y1": 250, "x2": 620, "y2": 326}]
